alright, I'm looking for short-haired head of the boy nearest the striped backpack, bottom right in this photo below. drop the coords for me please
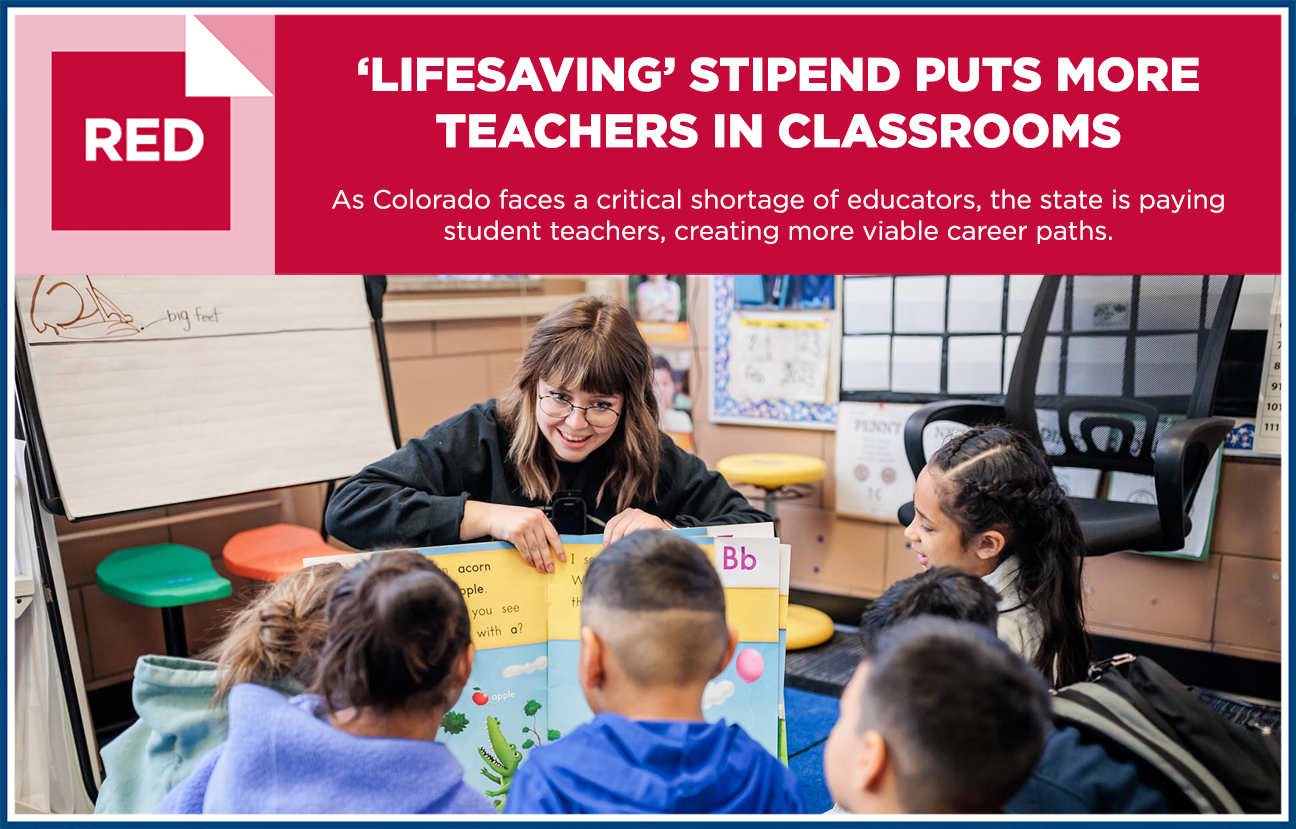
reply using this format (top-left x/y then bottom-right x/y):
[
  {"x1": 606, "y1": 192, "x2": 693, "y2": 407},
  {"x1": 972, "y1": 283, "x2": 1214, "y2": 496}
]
[{"x1": 857, "y1": 617, "x2": 1048, "y2": 813}]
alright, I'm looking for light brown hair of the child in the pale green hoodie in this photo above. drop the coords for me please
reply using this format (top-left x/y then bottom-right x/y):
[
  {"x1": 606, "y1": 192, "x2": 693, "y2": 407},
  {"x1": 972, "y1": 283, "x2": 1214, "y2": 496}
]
[{"x1": 205, "y1": 563, "x2": 343, "y2": 699}]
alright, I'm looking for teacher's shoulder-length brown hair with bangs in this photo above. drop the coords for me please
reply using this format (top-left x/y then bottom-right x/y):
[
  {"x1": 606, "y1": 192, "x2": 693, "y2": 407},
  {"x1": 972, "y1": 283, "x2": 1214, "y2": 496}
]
[{"x1": 499, "y1": 291, "x2": 661, "y2": 512}]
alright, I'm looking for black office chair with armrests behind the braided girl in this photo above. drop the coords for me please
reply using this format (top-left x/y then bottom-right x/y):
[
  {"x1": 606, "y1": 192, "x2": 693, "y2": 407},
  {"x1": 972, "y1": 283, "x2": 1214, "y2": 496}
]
[{"x1": 899, "y1": 276, "x2": 1242, "y2": 556}]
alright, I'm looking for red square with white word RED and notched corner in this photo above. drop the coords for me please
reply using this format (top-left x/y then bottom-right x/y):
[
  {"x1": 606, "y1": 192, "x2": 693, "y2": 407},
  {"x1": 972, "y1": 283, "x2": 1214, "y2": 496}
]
[{"x1": 51, "y1": 52, "x2": 229, "y2": 231}]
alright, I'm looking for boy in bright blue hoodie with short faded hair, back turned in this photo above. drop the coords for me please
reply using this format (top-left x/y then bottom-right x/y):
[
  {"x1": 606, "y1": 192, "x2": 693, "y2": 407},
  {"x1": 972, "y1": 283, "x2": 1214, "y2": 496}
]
[{"x1": 504, "y1": 531, "x2": 805, "y2": 815}]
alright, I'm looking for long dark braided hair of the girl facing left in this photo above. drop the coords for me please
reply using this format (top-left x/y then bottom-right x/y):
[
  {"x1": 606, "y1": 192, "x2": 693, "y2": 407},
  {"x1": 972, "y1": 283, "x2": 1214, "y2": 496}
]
[{"x1": 928, "y1": 426, "x2": 1089, "y2": 685}]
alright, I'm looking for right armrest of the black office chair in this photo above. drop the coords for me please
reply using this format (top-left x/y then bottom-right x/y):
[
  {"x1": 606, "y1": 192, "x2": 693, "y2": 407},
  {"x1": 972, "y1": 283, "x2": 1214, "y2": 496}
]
[{"x1": 1152, "y1": 417, "x2": 1234, "y2": 551}]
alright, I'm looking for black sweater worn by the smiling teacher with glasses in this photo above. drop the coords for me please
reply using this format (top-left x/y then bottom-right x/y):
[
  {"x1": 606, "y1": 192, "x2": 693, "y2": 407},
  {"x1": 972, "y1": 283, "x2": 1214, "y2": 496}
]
[{"x1": 325, "y1": 400, "x2": 770, "y2": 549}]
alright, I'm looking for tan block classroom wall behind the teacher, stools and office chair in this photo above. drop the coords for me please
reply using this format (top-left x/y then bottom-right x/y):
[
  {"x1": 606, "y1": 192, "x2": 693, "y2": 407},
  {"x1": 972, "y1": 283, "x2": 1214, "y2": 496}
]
[{"x1": 56, "y1": 280, "x2": 1282, "y2": 688}]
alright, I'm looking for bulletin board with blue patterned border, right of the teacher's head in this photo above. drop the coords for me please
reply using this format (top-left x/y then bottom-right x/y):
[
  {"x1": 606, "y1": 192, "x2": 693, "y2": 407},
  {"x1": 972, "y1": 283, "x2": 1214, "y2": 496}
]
[{"x1": 710, "y1": 276, "x2": 840, "y2": 429}]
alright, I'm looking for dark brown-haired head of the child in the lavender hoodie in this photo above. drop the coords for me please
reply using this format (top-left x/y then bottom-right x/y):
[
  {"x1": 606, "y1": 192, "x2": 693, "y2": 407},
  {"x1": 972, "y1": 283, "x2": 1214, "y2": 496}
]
[{"x1": 315, "y1": 552, "x2": 472, "y2": 712}]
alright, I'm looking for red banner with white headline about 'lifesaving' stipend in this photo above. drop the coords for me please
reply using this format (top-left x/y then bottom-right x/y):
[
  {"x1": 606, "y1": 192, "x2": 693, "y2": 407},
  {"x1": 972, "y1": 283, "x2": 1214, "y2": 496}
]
[{"x1": 270, "y1": 14, "x2": 1283, "y2": 273}]
